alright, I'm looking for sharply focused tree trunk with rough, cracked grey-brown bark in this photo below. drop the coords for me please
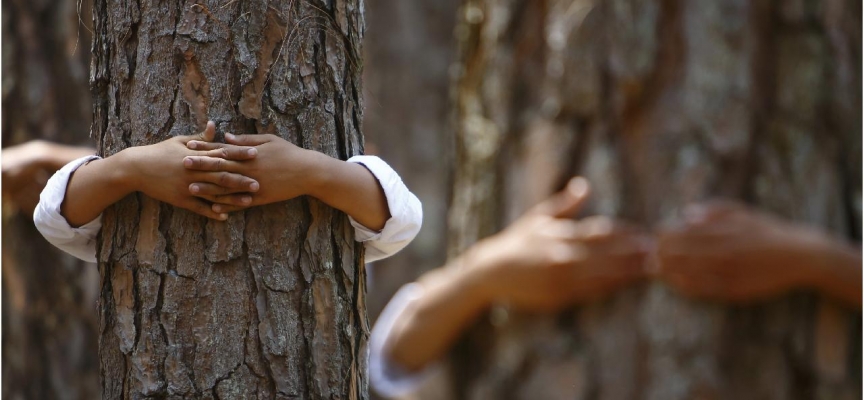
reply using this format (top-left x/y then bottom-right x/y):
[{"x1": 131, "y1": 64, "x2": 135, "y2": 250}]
[{"x1": 91, "y1": 0, "x2": 368, "y2": 399}]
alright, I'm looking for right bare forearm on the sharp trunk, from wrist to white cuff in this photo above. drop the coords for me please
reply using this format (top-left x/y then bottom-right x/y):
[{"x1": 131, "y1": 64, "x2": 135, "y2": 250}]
[{"x1": 309, "y1": 153, "x2": 390, "y2": 231}]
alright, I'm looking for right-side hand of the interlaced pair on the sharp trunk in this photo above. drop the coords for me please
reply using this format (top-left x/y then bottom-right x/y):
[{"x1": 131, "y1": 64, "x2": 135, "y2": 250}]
[{"x1": 183, "y1": 134, "x2": 329, "y2": 212}]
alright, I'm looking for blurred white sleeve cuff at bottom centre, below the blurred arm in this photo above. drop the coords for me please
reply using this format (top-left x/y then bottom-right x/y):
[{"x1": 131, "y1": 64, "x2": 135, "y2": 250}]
[{"x1": 369, "y1": 283, "x2": 444, "y2": 398}]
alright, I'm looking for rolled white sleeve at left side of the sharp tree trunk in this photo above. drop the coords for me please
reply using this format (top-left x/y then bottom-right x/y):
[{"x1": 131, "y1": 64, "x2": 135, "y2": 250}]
[{"x1": 33, "y1": 156, "x2": 102, "y2": 262}]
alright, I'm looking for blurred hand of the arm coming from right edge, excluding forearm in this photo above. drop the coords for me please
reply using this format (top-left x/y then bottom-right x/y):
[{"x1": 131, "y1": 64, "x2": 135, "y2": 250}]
[{"x1": 657, "y1": 202, "x2": 823, "y2": 301}]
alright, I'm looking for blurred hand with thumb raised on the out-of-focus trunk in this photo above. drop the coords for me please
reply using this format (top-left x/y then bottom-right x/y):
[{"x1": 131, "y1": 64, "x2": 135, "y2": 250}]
[{"x1": 465, "y1": 178, "x2": 648, "y2": 312}]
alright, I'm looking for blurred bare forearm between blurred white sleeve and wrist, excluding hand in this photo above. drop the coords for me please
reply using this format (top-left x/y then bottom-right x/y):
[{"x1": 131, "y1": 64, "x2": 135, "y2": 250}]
[{"x1": 384, "y1": 260, "x2": 489, "y2": 371}]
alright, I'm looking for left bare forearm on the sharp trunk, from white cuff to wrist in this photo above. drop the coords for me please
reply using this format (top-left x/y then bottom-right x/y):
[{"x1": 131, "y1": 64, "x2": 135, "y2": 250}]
[{"x1": 60, "y1": 150, "x2": 135, "y2": 227}]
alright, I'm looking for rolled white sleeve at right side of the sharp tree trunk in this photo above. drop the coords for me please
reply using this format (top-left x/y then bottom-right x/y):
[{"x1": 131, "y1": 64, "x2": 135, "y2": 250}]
[{"x1": 348, "y1": 156, "x2": 423, "y2": 263}]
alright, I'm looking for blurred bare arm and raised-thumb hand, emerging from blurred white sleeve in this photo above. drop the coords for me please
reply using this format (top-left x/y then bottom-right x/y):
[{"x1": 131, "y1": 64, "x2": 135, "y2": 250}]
[{"x1": 384, "y1": 178, "x2": 646, "y2": 371}]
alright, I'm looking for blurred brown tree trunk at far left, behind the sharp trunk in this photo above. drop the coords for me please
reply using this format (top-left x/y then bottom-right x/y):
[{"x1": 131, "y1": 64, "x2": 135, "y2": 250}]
[{"x1": 2, "y1": 0, "x2": 99, "y2": 399}]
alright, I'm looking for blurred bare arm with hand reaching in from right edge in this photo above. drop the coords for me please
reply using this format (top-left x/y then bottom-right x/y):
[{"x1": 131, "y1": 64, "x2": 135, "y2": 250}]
[{"x1": 658, "y1": 202, "x2": 861, "y2": 309}]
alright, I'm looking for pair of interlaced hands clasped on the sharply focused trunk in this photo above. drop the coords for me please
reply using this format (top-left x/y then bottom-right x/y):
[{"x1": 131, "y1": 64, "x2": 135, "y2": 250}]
[{"x1": 129, "y1": 122, "x2": 315, "y2": 220}]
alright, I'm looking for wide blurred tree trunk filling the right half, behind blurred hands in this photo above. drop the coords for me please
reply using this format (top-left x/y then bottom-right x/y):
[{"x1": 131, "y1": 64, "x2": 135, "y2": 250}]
[{"x1": 442, "y1": 0, "x2": 861, "y2": 400}]
